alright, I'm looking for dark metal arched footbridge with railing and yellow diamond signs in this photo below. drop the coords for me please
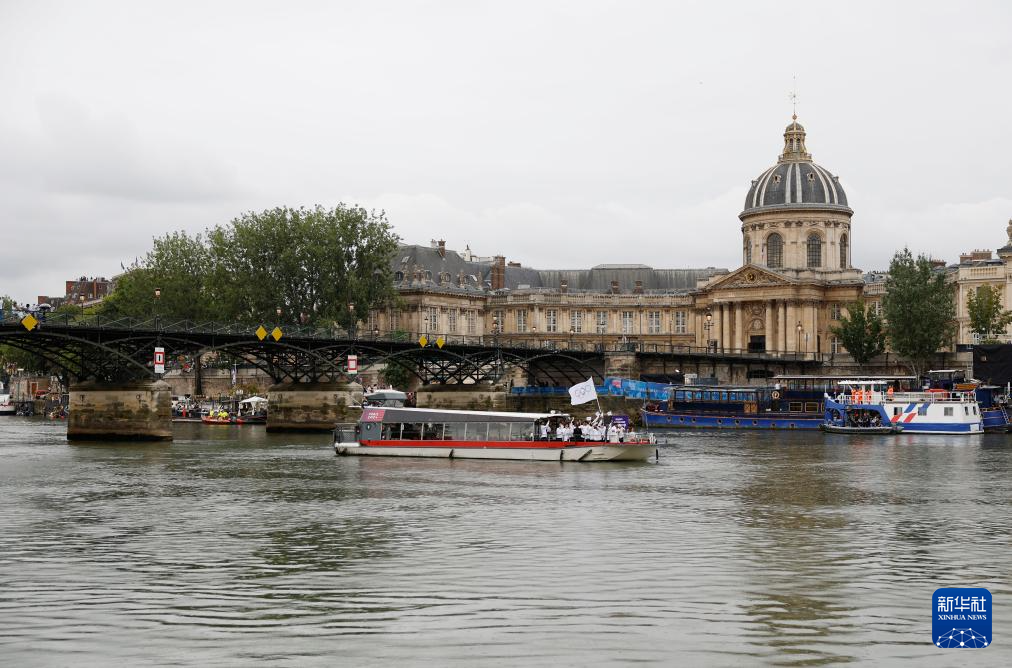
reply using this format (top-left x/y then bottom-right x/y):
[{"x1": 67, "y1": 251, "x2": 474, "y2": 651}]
[{"x1": 0, "y1": 313, "x2": 823, "y2": 385}]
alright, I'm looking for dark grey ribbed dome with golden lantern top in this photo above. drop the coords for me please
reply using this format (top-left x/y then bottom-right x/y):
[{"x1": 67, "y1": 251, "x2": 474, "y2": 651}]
[{"x1": 741, "y1": 116, "x2": 853, "y2": 216}]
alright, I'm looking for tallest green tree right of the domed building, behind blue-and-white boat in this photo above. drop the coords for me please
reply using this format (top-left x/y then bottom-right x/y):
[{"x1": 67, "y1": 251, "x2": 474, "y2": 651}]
[{"x1": 882, "y1": 248, "x2": 955, "y2": 377}]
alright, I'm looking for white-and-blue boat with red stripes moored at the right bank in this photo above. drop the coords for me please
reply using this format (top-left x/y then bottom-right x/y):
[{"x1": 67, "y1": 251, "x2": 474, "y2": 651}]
[{"x1": 825, "y1": 381, "x2": 984, "y2": 434}]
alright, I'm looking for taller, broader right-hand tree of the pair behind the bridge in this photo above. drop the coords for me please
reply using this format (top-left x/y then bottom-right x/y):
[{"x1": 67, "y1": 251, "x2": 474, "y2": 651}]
[{"x1": 208, "y1": 204, "x2": 400, "y2": 329}]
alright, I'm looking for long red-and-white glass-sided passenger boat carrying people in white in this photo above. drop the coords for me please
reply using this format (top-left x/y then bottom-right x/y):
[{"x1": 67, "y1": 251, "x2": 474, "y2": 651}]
[{"x1": 334, "y1": 408, "x2": 657, "y2": 462}]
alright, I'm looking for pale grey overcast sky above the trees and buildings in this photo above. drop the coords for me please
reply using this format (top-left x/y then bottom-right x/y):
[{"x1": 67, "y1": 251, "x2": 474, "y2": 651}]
[{"x1": 0, "y1": 0, "x2": 1012, "y2": 302}]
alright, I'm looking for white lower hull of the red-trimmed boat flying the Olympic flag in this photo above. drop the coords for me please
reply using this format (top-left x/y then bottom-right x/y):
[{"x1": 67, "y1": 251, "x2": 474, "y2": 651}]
[{"x1": 334, "y1": 443, "x2": 657, "y2": 462}]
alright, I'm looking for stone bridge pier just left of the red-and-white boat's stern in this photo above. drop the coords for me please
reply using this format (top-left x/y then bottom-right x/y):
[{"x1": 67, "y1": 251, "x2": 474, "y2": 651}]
[{"x1": 267, "y1": 383, "x2": 362, "y2": 431}]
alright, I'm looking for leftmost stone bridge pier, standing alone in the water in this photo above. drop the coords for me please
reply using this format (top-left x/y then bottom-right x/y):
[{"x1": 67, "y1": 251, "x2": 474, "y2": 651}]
[{"x1": 67, "y1": 381, "x2": 172, "y2": 440}]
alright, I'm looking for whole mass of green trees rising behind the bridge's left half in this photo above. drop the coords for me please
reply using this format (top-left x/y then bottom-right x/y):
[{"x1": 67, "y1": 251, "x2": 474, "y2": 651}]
[{"x1": 107, "y1": 204, "x2": 399, "y2": 328}]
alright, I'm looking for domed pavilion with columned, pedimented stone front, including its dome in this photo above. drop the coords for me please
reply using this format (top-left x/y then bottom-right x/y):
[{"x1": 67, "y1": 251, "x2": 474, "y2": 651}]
[{"x1": 695, "y1": 116, "x2": 863, "y2": 355}]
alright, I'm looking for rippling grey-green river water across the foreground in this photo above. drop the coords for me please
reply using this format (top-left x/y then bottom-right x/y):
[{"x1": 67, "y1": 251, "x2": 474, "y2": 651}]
[{"x1": 0, "y1": 418, "x2": 1012, "y2": 666}]
